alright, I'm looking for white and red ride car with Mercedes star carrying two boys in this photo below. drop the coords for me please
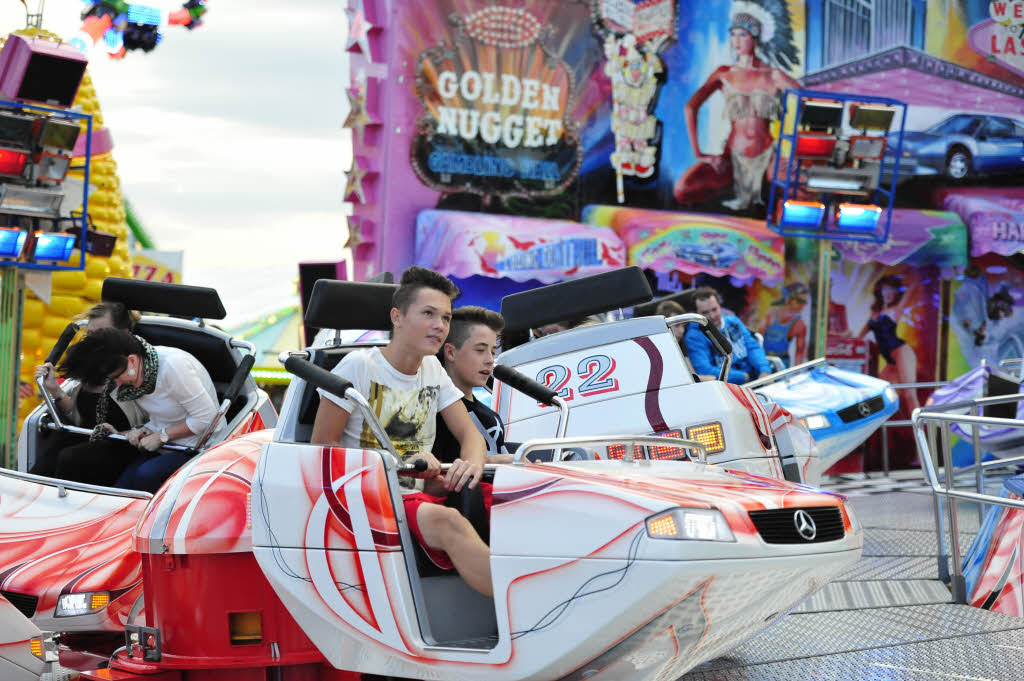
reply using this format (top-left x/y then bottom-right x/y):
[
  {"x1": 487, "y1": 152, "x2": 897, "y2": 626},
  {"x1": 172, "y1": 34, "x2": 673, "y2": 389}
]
[{"x1": 0, "y1": 270, "x2": 862, "y2": 681}]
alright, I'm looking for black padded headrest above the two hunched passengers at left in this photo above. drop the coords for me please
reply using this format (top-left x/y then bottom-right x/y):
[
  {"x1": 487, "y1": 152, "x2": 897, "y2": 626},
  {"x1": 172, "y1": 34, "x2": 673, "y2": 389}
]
[{"x1": 100, "y1": 276, "x2": 227, "y2": 320}]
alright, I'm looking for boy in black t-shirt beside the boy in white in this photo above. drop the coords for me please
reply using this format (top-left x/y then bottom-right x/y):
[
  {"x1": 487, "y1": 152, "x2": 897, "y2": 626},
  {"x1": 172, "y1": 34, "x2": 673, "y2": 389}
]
[{"x1": 434, "y1": 306, "x2": 512, "y2": 463}]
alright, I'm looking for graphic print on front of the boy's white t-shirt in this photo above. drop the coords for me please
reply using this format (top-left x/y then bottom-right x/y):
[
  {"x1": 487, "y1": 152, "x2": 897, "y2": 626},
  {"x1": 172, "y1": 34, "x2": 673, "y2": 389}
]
[{"x1": 359, "y1": 381, "x2": 440, "y2": 457}]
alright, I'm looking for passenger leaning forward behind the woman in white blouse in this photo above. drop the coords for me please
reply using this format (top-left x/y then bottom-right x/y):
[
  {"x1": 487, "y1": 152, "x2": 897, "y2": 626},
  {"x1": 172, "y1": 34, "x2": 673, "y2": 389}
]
[{"x1": 29, "y1": 303, "x2": 139, "y2": 477}]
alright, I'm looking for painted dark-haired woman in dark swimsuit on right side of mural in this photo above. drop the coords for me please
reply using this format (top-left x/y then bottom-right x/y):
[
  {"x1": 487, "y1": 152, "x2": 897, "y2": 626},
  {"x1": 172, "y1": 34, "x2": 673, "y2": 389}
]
[{"x1": 859, "y1": 274, "x2": 920, "y2": 410}]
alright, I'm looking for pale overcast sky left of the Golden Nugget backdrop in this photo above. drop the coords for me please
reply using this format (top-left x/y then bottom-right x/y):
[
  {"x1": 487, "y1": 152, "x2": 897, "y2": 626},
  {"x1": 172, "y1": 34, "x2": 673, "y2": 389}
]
[{"x1": 0, "y1": 0, "x2": 350, "y2": 325}]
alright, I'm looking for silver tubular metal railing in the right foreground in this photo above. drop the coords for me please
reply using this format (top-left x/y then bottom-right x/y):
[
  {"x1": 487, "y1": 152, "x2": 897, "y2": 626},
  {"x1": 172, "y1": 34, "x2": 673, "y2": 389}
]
[{"x1": 910, "y1": 393, "x2": 1024, "y2": 603}]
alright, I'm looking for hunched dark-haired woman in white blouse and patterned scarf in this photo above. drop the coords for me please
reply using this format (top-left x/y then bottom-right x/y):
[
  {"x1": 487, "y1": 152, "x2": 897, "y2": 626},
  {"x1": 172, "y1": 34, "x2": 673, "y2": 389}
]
[{"x1": 56, "y1": 329, "x2": 223, "y2": 492}]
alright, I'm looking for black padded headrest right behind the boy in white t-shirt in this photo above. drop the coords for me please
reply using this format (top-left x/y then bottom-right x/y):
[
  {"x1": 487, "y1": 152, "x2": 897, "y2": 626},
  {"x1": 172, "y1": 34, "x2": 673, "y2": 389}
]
[{"x1": 305, "y1": 279, "x2": 398, "y2": 331}]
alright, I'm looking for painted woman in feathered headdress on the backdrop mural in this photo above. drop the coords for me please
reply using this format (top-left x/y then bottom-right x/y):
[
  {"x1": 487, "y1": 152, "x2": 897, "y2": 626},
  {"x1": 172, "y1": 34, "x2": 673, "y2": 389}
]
[{"x1": 674, "y1": 0, "x2": 800, "y2": 211}]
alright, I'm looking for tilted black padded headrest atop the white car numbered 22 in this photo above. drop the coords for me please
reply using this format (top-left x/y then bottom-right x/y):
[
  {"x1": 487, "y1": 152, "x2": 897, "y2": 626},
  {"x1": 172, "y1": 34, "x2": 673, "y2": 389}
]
[{"x1": 502, "y1": 265, "x2": 653, "y2": 334}]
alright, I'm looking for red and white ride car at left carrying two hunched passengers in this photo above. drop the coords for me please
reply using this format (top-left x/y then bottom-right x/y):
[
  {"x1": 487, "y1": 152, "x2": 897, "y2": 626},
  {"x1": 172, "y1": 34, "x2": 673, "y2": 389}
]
[{"x1": 0, "y1": 278, "x2": 276, "y2": 656}]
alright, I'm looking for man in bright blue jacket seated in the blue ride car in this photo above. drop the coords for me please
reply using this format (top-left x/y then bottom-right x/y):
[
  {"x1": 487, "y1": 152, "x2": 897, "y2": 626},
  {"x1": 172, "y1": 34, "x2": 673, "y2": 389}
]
[{"x1": 683, "y1": 287, "x2": 771, "y2": 384}]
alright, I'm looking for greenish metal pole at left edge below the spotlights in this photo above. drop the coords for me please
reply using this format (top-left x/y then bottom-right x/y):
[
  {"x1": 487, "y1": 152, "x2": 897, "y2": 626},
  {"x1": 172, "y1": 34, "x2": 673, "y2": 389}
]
[{"x1": 0, "y1": 267, "x2": 25, "y2": 468}]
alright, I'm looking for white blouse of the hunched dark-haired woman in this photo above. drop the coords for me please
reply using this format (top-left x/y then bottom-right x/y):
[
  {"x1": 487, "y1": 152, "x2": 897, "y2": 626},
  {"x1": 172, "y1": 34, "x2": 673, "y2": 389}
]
[{"x1": 135, "y1": 345, "x2": 224, "y2": 446}]
